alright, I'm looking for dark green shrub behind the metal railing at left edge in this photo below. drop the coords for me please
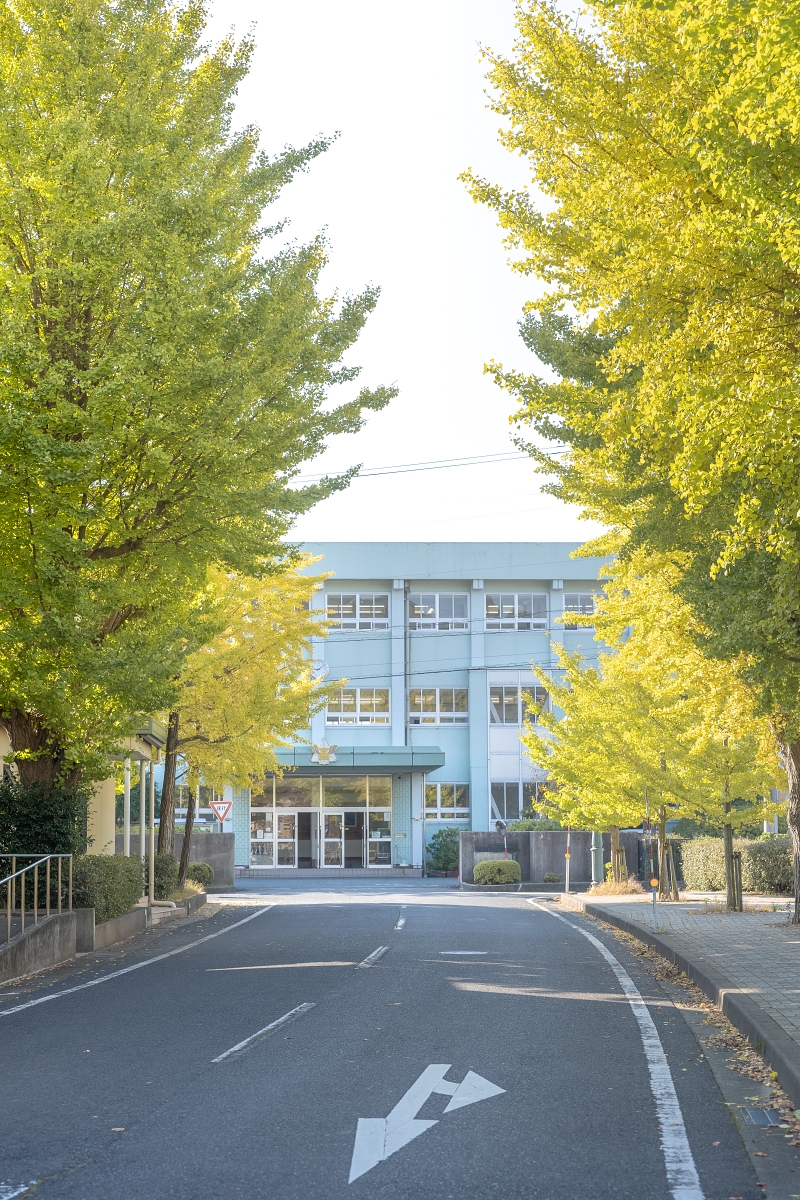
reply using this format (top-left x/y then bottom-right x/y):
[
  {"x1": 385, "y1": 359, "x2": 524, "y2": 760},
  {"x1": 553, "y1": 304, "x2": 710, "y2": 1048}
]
[{"x1": 0, "y1": 779, "x2": 89, "y2": 854}]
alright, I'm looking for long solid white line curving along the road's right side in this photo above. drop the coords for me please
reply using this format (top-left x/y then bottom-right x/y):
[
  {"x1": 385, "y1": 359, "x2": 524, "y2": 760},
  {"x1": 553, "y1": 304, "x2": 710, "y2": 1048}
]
[{"x1": 528, "y1": 900, "x2": 704, "y2": 1200}]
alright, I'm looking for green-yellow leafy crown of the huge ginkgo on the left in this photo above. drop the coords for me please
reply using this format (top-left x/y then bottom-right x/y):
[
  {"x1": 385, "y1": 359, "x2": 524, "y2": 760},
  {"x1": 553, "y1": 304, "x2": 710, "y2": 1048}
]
[{"x1": 0, "y1": 0, "x2": 393, "y2": 782}]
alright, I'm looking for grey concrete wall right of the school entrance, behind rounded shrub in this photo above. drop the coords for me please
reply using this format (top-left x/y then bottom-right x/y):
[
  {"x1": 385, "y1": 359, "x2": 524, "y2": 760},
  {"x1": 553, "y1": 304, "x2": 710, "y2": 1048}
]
[{"x1": 459, "y1": 829, "x2": 639, "y2": 883}]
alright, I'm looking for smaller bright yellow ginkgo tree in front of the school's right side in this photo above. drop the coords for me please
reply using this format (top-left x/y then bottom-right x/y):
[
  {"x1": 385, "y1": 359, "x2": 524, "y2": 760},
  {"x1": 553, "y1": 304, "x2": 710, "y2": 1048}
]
[{"x1": 523, "y1": 556, "x2": 780, "y2": 892}]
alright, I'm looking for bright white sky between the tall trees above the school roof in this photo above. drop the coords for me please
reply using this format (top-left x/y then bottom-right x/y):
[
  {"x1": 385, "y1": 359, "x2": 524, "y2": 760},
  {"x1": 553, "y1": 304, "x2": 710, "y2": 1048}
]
[{"x1": 210, "y1": 0, "x2": 597, "y2": 541}]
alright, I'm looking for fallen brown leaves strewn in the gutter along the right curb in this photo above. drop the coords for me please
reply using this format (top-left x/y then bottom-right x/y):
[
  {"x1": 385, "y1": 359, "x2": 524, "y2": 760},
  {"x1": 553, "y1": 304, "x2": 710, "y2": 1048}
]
[{"x1": 584, "y1": 914, "x2": 800, "y2": 1147}]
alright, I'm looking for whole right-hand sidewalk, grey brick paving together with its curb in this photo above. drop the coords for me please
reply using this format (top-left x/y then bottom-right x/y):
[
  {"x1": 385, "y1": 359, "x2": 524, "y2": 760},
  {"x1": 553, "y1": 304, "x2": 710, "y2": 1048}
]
[{"x1": 560, "y1": 895, "x2": 800, "y2": 1106}]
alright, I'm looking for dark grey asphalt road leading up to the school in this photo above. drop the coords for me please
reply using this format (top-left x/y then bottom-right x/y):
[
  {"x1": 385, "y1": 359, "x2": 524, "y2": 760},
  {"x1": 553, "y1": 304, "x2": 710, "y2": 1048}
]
[{"x1": 0, "y1": 886, "x2": 767, "y2": 1200}]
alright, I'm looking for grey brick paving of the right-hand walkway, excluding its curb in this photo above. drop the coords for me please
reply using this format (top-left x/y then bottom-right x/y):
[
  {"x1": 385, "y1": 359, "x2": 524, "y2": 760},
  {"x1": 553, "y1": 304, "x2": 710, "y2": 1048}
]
[{"x1": 569, "y1": 895, "x2": 800, "y2": 1046}]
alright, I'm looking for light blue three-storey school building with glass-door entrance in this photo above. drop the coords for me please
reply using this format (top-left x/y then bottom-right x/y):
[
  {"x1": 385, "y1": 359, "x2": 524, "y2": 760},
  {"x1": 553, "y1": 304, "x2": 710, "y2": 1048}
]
[{"x1": 228, "y1": 542, "x2": 604, "y2": 874}]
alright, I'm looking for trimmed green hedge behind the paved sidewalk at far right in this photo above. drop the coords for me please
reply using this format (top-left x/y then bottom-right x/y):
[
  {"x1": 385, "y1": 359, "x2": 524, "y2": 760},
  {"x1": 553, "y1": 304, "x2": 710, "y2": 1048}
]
[{"x1": 681, "y1": 838, "x2": 794, "y2": 895}]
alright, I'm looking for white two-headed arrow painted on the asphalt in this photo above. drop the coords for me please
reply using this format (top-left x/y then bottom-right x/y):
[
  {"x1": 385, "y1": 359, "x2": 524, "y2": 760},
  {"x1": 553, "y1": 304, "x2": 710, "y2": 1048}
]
[{"x1": 348, "y1": 1063, "x2": 505, "y2": 1183}]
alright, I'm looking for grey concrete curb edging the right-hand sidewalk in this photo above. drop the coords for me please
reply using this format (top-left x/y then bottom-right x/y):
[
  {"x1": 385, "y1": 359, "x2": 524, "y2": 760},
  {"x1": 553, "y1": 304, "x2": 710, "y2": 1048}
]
[{"x1": 564, "y1": 900, "x2": 800, "y2": 1106}]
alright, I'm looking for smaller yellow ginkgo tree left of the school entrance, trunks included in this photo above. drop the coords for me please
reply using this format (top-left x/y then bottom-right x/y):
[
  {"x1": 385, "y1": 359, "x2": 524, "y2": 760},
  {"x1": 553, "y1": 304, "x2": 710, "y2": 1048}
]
[{"x1": 158, "y1": 556, "x2": 327, "y2": 878}]
